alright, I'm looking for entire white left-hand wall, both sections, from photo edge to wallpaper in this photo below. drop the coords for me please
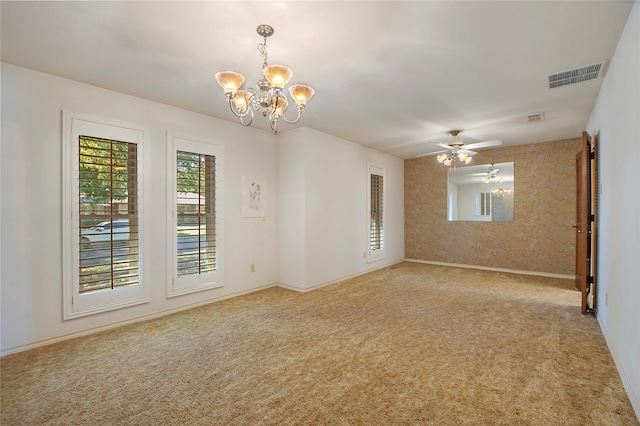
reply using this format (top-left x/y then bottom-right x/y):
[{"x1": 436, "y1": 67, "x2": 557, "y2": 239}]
[{"x1": 0, "y1": 63, "x2": 404, "y2": 355}]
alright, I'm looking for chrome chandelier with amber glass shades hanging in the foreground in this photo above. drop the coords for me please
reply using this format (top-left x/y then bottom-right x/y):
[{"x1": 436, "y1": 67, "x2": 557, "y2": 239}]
[{"x1": 215, "y1": 25, "x2": 315, "y2": 133}]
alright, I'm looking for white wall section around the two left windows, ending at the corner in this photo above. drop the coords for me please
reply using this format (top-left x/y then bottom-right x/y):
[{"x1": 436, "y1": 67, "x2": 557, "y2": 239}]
[{"x1": 0, "y1": 63, "x2": 277, "y2": 354}]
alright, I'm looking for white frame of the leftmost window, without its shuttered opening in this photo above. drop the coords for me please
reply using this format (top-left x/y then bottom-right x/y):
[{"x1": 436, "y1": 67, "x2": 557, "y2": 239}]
[{"x1": 62, "y1": 111, "x2": 150, "y2": 320}]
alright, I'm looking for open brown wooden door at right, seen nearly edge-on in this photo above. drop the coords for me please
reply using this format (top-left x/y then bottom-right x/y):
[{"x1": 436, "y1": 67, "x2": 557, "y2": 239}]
[{"x1": 574, "y1": 132, "x2": 593, "y2": 314}]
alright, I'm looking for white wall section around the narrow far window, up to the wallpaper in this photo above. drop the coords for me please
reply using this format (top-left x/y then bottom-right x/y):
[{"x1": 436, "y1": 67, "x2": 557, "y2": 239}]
[{"x1": 278, "y1": 127, "x2": 404, "y2": 290}]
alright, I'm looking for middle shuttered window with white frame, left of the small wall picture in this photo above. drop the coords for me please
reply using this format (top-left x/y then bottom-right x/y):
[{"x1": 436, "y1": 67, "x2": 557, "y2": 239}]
[{"x1": 167, "y1": 133, "x2": 222, "y2": 297}]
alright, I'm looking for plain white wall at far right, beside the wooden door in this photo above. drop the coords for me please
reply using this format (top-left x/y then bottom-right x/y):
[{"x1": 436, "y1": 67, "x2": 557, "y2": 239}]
[{"x1": 585, "y1": 1, "x2": 640, "y2": 418}]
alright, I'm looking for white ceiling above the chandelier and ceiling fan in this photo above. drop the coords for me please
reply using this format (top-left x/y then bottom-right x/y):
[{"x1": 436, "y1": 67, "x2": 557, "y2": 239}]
[{"x1": 1, "y1": 1, "x2": 633, "y2": 158}]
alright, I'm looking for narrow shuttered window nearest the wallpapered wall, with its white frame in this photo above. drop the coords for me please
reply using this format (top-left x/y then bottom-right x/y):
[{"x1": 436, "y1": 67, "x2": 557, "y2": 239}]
[{"x1": 367, "y1": 166, "x2": 385, "y2": 262}]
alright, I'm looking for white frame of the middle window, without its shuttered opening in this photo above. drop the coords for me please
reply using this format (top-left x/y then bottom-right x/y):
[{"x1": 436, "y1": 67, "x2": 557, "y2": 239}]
[{"x1": 167, "y1": 132, "x2": 224, "y2": 298}]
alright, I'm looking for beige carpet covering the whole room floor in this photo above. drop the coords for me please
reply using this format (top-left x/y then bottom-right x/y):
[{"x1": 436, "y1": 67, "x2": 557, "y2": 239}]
[{"x1": 0, "y1": 263, "x2": 638, "y2": 425}]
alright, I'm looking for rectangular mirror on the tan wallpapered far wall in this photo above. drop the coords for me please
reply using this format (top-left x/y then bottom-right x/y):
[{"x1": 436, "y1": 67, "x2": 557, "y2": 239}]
[{"x1": 447, "y1": 162, "x2": 515, "y2": 222}]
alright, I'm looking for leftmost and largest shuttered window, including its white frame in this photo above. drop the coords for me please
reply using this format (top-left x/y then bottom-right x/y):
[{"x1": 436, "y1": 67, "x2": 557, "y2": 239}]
[{"x1": 63, "y1": 113, "x2": 148, "y2": 319}]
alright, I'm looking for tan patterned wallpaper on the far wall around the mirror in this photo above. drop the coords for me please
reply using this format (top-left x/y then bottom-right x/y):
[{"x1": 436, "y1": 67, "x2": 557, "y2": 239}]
[{"x1": 404, "y1": 138, "x2": 581, "y2": 275}]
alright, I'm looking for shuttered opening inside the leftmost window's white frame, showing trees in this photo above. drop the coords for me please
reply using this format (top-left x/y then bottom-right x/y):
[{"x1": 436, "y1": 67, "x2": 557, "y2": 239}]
[{"x1": 78, "y1": 136, "x2": 140, "y2": 294}]
